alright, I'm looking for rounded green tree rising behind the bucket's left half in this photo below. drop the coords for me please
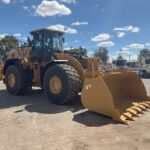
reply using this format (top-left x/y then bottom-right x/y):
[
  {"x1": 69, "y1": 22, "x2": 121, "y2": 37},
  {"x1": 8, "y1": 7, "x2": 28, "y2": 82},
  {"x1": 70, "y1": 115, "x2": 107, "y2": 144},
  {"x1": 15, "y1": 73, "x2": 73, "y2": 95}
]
[{"x1": 94, "y1": 47, "x2": 109, "y2": 65}]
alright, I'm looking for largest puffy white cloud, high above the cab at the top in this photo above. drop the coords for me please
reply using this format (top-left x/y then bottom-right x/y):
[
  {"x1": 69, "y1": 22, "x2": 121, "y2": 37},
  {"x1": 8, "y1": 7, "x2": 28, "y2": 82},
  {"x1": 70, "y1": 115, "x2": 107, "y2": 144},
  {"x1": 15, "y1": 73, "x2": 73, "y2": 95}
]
[{"x1": 35, "y1": 0, "x2": 72, "y2": 17}]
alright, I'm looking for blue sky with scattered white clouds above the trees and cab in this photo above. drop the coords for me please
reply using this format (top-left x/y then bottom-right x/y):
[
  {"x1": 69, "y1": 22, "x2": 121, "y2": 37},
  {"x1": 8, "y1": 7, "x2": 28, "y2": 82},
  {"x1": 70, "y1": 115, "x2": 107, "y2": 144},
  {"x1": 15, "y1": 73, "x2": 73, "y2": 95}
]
[{"x1": 0, "y1": 0, "x2": 150, "y2": 60}]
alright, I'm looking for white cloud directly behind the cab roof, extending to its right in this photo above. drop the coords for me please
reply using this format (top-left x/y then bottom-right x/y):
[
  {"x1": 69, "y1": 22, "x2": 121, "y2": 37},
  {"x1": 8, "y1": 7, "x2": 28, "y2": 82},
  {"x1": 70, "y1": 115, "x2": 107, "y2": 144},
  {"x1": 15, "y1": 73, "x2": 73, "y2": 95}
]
[{"x1": 48, "y1": 24, "x2": 77, "y2": 34}]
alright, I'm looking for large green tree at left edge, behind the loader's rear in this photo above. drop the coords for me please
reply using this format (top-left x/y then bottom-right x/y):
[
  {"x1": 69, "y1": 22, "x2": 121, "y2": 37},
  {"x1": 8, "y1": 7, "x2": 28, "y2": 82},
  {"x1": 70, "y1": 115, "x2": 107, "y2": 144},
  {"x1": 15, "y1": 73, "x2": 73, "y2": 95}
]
[{"x1": 0, "y1": 35, "x2": 19, "y2": 60}]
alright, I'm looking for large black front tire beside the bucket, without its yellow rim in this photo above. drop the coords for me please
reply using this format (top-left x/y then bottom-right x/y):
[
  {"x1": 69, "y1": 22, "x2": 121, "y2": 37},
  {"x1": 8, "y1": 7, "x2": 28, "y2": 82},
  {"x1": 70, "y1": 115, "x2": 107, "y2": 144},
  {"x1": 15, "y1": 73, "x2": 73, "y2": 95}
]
[{"x1": 43, "y1": 64, "x2": 81, "y2": 105}]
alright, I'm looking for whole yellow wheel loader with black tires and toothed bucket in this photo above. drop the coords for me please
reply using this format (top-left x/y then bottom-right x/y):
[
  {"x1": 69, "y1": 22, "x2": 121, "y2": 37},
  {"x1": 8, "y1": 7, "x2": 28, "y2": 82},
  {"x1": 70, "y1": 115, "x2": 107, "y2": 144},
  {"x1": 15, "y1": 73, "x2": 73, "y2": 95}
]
[{"x1": 0, "y1": 29, "x2": 150, "y2": 124}]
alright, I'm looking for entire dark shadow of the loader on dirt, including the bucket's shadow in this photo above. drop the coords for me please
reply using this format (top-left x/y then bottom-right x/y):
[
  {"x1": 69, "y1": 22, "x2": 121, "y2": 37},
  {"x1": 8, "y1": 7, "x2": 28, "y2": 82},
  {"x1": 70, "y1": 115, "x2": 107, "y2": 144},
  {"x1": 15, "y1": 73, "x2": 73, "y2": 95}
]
[{"x1": 0, "y1": 90, "x2": 117, "y2": 127}]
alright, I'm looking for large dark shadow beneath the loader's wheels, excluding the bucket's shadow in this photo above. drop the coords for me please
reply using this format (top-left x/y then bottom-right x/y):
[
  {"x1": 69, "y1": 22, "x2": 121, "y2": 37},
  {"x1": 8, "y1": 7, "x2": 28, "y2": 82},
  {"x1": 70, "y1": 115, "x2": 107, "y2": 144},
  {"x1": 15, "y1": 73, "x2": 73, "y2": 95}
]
[{"x1": 0, "y1": 90, "x2": 84, "y2": 114}]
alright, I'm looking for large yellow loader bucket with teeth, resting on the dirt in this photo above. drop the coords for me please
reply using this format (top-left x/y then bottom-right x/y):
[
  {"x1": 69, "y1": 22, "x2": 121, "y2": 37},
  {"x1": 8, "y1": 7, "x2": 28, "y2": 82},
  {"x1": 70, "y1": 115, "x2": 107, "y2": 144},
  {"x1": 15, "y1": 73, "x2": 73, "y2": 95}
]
[{"x1": 81, "y1": 70, "x2": 150, "y2": 124}]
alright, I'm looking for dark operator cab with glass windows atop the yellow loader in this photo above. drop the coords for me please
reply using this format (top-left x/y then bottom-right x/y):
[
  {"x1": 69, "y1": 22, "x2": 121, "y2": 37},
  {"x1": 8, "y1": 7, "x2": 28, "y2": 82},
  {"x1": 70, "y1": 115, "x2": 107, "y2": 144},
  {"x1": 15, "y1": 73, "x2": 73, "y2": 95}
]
[{"x1": 28, "y1": 28, "x2": 64, "y2": 61}]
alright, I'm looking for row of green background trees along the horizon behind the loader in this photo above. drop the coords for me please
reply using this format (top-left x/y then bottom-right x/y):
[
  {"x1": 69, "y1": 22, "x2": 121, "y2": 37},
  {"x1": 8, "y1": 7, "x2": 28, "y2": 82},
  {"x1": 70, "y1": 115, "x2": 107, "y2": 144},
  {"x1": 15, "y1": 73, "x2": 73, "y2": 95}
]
[{"x1": 0, "y1": 35, "x2": 150, "y2": 64}]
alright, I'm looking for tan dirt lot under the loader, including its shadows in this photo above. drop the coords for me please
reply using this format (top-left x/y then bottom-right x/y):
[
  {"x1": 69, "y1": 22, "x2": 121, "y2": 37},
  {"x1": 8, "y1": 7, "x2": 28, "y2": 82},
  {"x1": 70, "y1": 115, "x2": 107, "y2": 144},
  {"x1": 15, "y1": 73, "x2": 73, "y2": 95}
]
[{"x1": 0, "y1": 80, "x2": 150, "y2": 150}]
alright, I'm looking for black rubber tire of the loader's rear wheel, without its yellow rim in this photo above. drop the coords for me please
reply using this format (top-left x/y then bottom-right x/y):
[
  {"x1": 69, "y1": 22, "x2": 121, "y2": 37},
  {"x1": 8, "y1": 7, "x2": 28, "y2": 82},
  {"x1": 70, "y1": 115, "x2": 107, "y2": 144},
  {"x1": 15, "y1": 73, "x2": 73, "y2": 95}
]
[{"x1": 5, "y1": 65, "x2": 29, "y2": 95}]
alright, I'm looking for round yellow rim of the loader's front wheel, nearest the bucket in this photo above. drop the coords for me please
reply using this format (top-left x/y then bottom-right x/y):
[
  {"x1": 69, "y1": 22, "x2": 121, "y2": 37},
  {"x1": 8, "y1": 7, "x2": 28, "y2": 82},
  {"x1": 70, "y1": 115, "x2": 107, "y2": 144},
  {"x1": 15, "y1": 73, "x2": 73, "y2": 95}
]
[{"x1": 49, "y1": 76, "x2": 62, "y2": 94}]
